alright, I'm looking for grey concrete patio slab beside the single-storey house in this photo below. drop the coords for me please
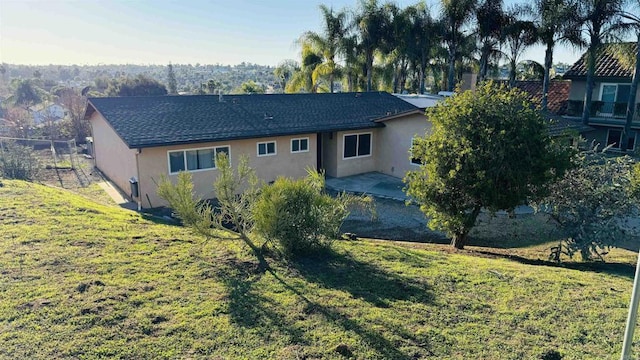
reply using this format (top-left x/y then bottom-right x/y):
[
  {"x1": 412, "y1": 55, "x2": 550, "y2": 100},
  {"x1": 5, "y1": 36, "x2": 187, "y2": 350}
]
[{"x1": 325, "y1": 172, "x2": 408, "y2": 201}]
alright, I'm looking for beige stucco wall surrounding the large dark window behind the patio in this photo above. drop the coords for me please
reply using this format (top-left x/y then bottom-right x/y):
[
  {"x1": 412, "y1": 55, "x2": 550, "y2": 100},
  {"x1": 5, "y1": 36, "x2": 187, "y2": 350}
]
[{"x1": 327, "y1": 129, "x2": 384, "y2": 177}]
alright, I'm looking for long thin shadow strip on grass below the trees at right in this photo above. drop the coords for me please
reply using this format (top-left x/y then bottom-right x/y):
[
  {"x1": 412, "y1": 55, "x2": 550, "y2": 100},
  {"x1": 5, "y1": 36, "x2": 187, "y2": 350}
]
[{"x1": 474, "y1": 250, "x2": 636, "y2": 278}]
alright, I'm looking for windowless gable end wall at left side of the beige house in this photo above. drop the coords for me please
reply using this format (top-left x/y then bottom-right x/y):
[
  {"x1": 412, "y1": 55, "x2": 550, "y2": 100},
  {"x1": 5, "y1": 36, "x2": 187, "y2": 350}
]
[{"x1": 89, "y1": 112, "x2": 138, "y2": 198}]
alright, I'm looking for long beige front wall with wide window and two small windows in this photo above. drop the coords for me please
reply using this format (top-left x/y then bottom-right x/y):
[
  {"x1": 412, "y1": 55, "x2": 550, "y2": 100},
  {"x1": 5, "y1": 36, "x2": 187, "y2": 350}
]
[{"x1": 138, "y1": 134, "x2": 317, "y2": 208}]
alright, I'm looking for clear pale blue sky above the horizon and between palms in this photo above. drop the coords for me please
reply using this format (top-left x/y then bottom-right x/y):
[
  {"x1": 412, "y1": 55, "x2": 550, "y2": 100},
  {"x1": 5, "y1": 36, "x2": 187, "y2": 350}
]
[{"x1": 0, "y1": 0, "x2": 580, "y2": 65}]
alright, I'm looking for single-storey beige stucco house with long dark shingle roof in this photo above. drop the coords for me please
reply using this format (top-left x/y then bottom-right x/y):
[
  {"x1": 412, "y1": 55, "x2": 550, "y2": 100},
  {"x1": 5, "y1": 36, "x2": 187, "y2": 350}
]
[{"x1": 85, "y1": 92, "x2": 430, "y2": 208}]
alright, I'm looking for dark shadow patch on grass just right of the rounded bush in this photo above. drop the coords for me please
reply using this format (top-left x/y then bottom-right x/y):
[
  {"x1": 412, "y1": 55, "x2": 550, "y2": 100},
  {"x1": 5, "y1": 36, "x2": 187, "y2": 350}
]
[{"x1": 293, "y1": 251, "x2": 433, "y2": 307}]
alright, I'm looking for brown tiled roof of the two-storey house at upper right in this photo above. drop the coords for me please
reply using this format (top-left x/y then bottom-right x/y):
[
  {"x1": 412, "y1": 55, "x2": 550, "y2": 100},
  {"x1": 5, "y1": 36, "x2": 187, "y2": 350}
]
[{"x1": 563, "y1": 42, "x2": 637, "y2": 79}]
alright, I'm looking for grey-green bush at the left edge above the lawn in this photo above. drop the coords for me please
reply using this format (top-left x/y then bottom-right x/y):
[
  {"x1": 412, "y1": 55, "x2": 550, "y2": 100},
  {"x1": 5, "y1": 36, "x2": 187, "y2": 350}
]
[{"x1": 0, "y1": 142, "x2": 42, "y2": 180}]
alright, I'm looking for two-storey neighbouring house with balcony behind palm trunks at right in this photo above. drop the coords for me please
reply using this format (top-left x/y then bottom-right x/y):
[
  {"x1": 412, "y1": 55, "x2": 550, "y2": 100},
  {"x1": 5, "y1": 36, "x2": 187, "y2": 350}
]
[{"x1": 563, "y1": 43, "x2": 640, "y2": 151}]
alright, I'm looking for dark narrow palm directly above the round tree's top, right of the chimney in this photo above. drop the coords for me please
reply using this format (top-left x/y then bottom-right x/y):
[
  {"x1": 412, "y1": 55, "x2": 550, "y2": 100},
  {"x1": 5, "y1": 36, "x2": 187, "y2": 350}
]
[{"x1": 476, "y1": 0, "x2": 505, "y2": 82}]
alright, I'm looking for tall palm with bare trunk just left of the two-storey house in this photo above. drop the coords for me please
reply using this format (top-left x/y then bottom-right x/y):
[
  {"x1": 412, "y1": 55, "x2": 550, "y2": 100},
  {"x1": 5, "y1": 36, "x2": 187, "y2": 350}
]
[{"x1": 527, "y1": 0, "x2": 581, "y2": 112}]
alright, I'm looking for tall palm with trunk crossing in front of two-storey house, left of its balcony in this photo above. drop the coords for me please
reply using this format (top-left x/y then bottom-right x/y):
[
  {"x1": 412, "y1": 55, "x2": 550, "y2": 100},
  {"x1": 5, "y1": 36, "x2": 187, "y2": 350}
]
[{"x1": 577, "y1": 0, "x2": 626, "y2": 125}]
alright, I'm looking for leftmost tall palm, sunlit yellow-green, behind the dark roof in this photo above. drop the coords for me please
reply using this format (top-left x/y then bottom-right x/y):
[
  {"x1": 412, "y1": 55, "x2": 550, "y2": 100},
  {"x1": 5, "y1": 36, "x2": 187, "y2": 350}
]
[{"x1": 302, "y1": 5, "x2": 347, "y2": 93}]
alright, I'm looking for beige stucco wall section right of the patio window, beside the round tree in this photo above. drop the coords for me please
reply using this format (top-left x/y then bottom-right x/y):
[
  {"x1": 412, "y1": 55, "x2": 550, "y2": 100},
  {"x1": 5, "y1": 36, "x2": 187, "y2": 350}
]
[{"x1": 376, "y1": 114, "x2": 431, "y2": 178}]
